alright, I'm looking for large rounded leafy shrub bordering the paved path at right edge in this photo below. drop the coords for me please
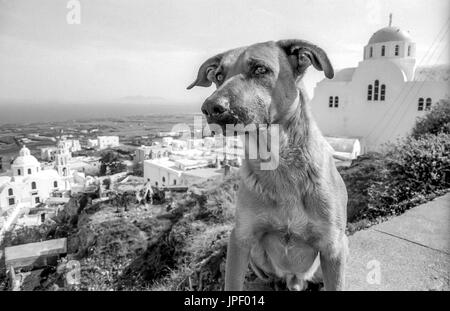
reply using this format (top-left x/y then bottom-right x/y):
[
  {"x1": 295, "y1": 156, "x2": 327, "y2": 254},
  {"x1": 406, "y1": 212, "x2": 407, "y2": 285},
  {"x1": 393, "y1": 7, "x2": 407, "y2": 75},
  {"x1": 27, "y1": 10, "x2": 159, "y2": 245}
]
[{"x1": 368, "y1": 133, "x2": 450, "y2": 217}]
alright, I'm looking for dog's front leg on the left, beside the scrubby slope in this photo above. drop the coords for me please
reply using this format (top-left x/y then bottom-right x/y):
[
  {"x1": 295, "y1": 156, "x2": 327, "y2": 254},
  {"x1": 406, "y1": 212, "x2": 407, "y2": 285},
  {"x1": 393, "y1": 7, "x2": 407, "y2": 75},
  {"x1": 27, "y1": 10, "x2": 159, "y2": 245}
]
[{"x1": 225, "y1": 229, "x2": 250, "y2": 291}]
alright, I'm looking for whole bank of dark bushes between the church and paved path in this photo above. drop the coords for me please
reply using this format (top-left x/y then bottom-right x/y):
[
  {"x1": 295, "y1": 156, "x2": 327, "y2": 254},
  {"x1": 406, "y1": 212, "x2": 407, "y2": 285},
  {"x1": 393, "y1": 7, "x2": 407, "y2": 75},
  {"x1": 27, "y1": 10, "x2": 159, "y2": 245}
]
[{"x1": 340, "y1": 100, "x2": 450, "y2": 231}]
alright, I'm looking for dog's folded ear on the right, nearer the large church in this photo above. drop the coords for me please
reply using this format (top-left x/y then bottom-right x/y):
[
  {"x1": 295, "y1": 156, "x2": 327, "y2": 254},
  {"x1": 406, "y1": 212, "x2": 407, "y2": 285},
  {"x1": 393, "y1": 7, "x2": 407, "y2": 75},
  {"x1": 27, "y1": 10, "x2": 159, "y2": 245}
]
[{"x1": 277, "y1": 39, "x2": 334, "y2": 79}]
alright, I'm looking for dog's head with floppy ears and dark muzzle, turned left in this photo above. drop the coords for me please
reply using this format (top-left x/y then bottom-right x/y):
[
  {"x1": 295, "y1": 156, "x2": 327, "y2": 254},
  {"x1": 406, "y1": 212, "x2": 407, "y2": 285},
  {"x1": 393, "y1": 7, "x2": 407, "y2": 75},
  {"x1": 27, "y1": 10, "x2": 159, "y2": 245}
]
[{"x1": 188, "y1": 40, "x2": 334, "y2": 130}]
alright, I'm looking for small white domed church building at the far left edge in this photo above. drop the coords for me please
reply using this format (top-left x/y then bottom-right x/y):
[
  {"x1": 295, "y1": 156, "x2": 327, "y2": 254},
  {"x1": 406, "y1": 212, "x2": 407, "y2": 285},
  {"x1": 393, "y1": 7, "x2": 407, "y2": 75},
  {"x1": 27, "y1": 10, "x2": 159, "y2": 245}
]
[{"x1": 0, "y1": 146, "x2": 70, "y2": 215}]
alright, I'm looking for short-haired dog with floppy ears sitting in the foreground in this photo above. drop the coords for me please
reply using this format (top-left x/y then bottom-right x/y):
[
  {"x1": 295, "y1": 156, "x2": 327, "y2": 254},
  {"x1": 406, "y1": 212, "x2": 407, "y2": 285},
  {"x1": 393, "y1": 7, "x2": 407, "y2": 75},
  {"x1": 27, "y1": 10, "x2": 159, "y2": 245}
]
[{"x1": 188, "y1": 40, "x2": 348, "y2": 290}]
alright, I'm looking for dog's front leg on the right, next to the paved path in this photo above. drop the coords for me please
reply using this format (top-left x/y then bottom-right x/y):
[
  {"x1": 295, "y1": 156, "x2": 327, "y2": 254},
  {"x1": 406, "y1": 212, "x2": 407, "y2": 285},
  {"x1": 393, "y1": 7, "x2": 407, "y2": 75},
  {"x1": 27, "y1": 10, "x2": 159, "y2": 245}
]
[{"x1": 320, "y1": 235, "x2": 348, "y2": 291}]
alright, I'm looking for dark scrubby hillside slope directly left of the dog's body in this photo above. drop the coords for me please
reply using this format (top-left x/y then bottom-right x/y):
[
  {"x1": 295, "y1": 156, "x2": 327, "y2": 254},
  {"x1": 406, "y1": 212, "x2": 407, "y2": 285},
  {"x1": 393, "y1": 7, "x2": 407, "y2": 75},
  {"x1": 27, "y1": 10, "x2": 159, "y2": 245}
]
[{"x1": 119, "y1": 175, "x2": 238, "y2": 290}]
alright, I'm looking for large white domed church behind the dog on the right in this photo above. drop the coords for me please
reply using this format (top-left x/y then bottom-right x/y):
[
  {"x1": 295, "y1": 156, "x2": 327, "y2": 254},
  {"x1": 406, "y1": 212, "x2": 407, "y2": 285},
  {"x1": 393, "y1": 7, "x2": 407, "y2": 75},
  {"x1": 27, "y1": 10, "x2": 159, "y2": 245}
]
[{"x1": 310, "y1": 18, "x2": 449, "y2": 153}]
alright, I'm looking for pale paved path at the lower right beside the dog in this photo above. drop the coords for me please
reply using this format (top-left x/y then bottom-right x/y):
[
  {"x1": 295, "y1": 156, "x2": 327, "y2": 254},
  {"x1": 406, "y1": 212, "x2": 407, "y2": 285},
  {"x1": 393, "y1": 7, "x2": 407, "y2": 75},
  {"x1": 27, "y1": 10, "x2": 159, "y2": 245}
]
[{"x1": 347, "y1": 193, "x2": 450, "y2": 290}]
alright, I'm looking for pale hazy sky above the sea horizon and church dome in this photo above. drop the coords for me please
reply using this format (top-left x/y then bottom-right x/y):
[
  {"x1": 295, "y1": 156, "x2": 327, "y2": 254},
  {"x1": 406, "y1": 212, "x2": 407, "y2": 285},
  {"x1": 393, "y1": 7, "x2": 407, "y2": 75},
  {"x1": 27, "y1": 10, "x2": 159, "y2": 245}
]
[{"x1": 0, "y1": 0, "x2": 450, "y2": 103}]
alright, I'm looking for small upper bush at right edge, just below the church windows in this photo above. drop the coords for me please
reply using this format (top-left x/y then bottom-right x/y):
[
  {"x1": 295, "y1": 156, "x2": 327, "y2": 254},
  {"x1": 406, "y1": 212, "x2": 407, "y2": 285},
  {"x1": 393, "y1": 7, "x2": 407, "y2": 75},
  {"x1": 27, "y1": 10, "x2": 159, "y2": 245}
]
[{"x1": 411, "y1": 99, "x2": 450, "y2": 138}]
